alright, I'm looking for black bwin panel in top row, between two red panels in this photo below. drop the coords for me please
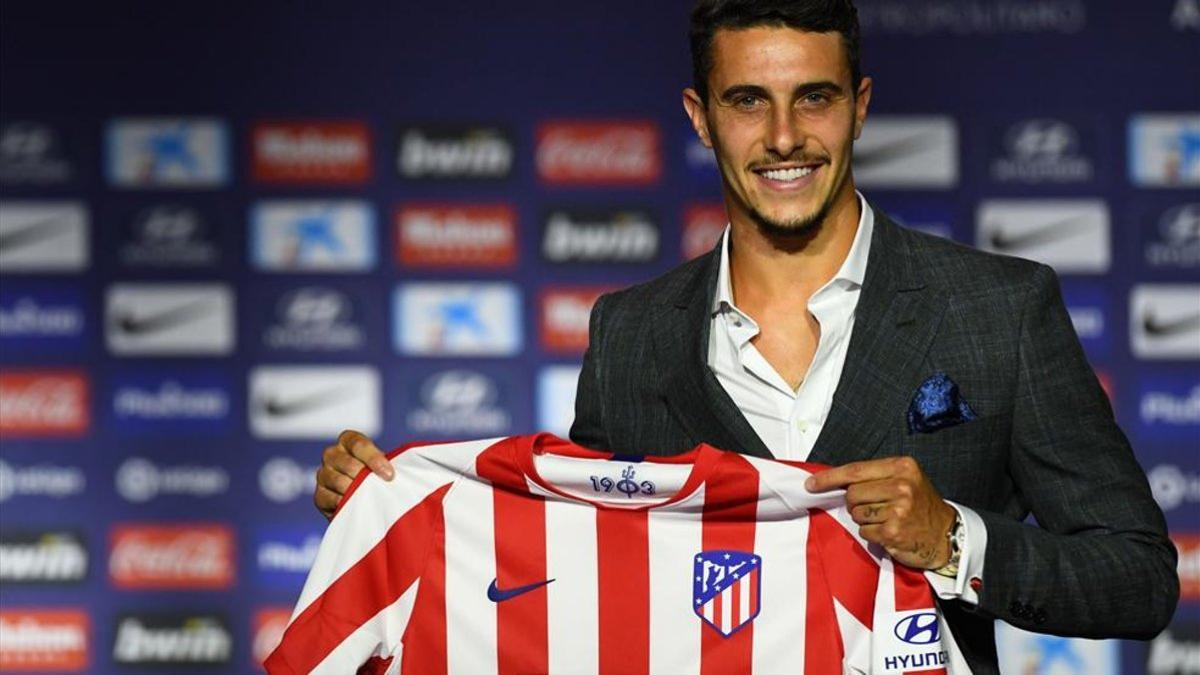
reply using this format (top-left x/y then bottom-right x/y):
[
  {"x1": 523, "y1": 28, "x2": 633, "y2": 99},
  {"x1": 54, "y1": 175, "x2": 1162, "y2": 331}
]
[{"x1": 396, "y1": 126, "x2": 515, "y2": 180}]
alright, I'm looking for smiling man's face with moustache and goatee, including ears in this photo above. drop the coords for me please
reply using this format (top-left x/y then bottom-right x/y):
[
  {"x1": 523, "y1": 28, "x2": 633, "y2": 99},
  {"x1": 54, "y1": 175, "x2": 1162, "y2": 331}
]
[{"x1": 684, "y1": 28, "x2": 871, "y2": 235}]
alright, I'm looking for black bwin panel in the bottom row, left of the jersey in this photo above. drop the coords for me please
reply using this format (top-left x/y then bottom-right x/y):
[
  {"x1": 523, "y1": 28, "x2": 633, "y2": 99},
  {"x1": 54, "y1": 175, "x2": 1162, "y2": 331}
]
[{"x1": 113, "y1": 613, "x2": 233, "y2": 668}]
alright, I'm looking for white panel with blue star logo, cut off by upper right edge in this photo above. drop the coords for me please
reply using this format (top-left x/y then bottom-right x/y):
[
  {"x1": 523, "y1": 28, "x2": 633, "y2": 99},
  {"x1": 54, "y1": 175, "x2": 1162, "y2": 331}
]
[{"x1": 1129, "y1": 113, "x2": 1200, "y2": 187}]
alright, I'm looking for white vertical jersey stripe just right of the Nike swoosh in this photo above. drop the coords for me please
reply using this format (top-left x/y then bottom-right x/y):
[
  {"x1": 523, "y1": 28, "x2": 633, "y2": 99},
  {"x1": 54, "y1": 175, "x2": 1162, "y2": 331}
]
[{"x1": 546, "y1": 497, "x2": 600, "y2": 675}]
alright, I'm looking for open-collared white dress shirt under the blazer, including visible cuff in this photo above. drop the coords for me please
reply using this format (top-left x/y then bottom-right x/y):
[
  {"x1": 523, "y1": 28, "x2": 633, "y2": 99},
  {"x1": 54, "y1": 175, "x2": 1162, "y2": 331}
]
[{"x1": 708, "y1": 195, "x2": 988, "y2": 604}]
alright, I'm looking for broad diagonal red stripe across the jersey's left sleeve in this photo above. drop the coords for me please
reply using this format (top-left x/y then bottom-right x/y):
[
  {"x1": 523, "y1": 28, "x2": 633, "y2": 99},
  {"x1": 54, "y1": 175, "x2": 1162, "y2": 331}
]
[{"x1": 264, "y1": 484, "x2": 450, "y2": 673}]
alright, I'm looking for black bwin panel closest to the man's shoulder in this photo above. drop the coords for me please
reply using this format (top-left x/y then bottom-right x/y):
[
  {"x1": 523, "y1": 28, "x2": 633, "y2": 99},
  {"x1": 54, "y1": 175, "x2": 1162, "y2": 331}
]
[{"x1": 541, "y1": 209, "x2": 660, "y2": 263}]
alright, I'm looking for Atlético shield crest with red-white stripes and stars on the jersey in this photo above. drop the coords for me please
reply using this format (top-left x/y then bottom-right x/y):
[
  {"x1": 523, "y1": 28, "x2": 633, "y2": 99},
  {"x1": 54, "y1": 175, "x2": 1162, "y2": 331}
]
[{"x1": 691, "y1": 551, "x2": 762, "y2": 638}]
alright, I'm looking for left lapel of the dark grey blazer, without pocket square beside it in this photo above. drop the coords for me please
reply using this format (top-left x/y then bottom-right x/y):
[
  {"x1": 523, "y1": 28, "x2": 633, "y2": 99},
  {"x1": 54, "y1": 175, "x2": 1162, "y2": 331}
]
[{"x1": 652, "y1": 246, "x2": 772, "y2": 458}]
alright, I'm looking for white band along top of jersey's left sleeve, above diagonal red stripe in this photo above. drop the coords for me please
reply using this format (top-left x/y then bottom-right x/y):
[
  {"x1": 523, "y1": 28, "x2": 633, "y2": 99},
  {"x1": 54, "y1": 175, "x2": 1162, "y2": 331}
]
[{"x1": 292, "y1": 438, "x2": 497, "y2": 619}]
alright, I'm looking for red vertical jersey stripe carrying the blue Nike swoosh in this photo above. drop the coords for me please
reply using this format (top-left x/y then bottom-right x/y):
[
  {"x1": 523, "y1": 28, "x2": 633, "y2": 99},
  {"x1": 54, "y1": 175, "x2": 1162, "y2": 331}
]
[{"x1": 475, "y1": 442, "x2": 550, "y2": 675}]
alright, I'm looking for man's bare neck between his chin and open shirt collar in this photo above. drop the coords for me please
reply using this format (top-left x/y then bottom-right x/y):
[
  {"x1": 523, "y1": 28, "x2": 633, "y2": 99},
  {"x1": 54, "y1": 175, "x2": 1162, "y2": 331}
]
[{"x1": 730, "y1": 186, "x2": 860, "y2": 300}]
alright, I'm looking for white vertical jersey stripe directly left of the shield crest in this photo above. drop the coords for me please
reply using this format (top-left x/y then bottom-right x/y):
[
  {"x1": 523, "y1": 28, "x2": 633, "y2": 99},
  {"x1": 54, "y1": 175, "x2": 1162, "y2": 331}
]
[{"x1": 647, "y1": 488, "x2": 713, "y2": 675}]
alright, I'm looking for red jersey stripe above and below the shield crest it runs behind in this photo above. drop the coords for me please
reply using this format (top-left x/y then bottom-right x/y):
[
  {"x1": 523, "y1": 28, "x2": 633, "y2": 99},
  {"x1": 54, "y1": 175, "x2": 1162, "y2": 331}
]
[{"x1": 700, "y1": 454, "x2": 753, "y2": 675}]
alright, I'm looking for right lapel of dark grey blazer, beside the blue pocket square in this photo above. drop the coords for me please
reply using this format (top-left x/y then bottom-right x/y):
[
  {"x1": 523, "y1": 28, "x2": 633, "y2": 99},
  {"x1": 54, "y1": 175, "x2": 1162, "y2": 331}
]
[{"x1": 809, "y1": 210, "x2": 946, "y2": 465}]
